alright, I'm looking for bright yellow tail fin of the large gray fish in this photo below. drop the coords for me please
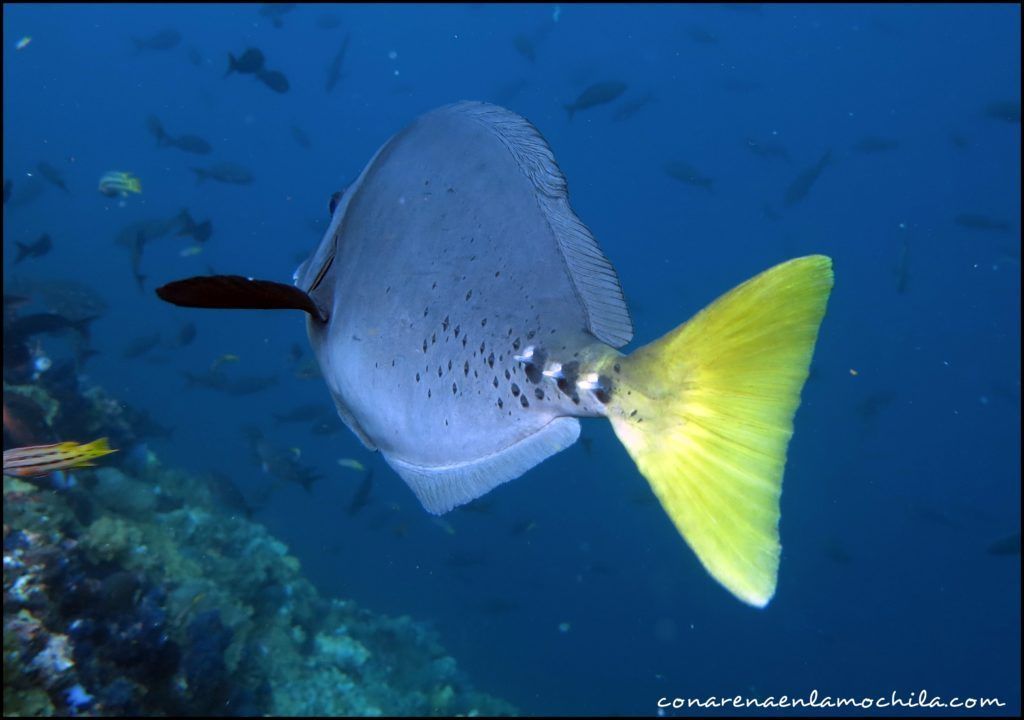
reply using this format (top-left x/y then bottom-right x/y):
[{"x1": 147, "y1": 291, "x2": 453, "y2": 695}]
[{"x1": 606, "y1": 255, "x2": 833, "y2": 607}]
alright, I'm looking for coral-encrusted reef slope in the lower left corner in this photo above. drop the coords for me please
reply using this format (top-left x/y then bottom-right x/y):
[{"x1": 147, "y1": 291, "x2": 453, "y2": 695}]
[{"x1": 3, "y1": 383, "x2": 515, "y2": 715}]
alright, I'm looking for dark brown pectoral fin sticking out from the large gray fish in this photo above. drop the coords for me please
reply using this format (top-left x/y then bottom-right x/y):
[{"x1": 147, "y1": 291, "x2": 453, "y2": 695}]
[{"x1": 157, "y1": 276, "x2": 328, "y2": 323}]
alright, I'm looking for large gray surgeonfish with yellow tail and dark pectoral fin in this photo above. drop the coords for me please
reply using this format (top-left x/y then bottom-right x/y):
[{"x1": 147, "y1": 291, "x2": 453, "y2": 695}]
[{"x1": 157, "y1": 101, "x2": 833, "y2": 606}]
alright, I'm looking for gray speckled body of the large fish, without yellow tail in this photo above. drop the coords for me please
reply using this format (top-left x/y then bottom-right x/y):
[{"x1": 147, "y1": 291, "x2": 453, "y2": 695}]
[{"x1": 296, "y1": 102, "x2": 632, "y2": 513}]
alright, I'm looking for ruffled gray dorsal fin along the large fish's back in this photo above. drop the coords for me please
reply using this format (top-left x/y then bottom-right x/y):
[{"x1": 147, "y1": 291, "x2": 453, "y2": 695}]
[{"x1": 448, "y1": 101, "x2": 633, "y2": 347}]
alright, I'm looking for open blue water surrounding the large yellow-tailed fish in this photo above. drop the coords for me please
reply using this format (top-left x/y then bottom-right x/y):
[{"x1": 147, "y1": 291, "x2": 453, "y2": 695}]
[{"x1": 3, "y1": 4, "x2": 1021, "y2": 714}]
